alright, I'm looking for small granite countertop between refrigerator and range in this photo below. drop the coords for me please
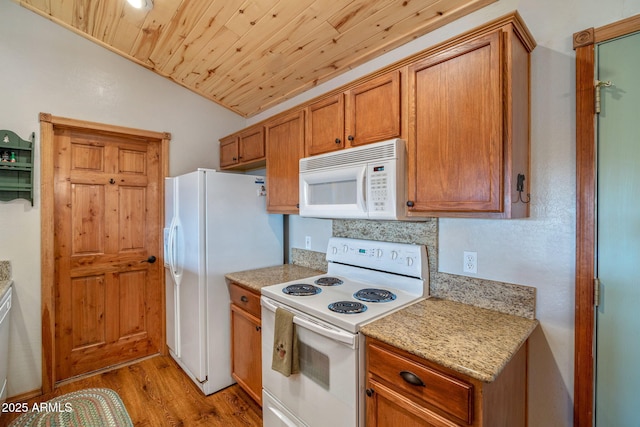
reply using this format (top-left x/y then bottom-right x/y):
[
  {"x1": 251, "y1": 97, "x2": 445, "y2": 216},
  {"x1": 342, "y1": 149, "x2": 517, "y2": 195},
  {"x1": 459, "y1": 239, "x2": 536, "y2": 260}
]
[{"x1": 225, "y1": 264, "x2": 323, "y2": 293}]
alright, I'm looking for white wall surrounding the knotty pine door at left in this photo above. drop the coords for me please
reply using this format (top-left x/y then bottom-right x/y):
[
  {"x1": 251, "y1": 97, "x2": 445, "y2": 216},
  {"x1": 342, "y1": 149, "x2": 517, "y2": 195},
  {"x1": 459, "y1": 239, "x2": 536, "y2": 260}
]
[{"x1": 0, "y1": 0, "x2": 246, "y2": 396}]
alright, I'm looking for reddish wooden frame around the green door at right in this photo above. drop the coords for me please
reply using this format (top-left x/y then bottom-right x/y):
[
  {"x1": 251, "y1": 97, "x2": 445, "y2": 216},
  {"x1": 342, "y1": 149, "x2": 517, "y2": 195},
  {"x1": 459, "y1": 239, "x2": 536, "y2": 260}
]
[{"x1": 573, "y1": 15, "x2": 640, "y2": 427}]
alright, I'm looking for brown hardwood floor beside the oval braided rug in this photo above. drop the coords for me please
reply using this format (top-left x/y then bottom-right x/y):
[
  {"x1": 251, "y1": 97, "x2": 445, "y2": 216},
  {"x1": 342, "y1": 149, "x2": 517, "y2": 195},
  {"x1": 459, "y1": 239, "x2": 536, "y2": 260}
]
[{"x1": 0, "y1": 356, "x2": 262, "y2": 427}]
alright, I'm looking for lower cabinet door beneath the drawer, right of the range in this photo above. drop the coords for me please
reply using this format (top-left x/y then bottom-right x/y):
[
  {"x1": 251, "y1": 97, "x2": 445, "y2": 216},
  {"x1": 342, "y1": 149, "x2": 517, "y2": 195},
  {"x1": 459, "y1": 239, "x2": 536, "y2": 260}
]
[{"x1": 366, "y1": 378, "x2": 460, "y2": 427}]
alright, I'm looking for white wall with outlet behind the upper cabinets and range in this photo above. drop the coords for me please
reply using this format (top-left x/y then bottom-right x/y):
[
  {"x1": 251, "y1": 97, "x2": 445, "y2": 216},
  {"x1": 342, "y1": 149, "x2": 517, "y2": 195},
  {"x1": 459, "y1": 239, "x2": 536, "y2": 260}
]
[{"x1": 249, "y1": 0, "x2": 640, "y2": 427}]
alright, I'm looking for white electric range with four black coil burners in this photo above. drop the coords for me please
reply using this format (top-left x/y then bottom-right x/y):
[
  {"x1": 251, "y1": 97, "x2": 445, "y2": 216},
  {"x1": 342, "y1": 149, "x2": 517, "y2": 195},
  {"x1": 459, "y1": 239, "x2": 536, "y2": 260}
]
[{"x1": 261, "y1": 237, "x2": 429, "y2": 427}]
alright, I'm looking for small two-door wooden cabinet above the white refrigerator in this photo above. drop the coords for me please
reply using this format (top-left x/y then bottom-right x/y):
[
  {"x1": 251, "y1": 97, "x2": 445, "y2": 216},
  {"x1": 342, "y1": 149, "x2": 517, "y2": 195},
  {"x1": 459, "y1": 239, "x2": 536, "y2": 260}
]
[{"x1": 220, "y1": 125, "x2": 265, "y2": 169}]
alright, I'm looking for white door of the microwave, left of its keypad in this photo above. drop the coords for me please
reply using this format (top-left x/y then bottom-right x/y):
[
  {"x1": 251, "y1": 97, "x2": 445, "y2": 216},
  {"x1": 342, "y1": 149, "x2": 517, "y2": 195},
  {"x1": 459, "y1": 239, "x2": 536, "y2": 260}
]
[{"x1": 300, "y1": 163, "x2": 367, "y2": 218}]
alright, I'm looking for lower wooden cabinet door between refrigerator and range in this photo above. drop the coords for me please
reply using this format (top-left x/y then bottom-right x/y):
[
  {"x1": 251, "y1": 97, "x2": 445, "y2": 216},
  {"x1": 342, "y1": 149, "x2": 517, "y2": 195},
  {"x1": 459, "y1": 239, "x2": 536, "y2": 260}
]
[{"x1": 231, "y1": 304, "x2": 262, "y2": 404}]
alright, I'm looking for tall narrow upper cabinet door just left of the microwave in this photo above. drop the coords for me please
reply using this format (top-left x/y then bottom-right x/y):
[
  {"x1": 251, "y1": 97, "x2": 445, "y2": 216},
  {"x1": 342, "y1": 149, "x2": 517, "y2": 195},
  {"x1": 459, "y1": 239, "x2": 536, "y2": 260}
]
[{"x1": 265, "y1": 110, "x2": 304, "y2": 214}]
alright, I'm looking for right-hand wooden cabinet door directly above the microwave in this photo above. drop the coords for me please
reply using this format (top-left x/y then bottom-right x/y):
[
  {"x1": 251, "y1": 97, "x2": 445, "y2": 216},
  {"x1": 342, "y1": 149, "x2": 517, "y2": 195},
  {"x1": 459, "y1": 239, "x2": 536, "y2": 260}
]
[{"x1": 345, "y1": 71, "x2": 401, "y2": 147}]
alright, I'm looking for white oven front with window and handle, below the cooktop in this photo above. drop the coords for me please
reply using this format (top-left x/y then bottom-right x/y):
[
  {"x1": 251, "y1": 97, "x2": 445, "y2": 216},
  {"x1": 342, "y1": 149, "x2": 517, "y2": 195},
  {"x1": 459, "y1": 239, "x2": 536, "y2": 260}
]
[{"x1": 261, "y1": 296, "x2": 359, "y2": 427}]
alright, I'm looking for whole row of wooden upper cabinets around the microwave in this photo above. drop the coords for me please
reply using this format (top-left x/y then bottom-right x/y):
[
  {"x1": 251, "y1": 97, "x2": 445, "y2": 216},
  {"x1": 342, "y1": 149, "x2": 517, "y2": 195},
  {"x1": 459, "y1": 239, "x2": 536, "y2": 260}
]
[{"x1": 220, "y1": 12, "x2": 535, "y2": 218}]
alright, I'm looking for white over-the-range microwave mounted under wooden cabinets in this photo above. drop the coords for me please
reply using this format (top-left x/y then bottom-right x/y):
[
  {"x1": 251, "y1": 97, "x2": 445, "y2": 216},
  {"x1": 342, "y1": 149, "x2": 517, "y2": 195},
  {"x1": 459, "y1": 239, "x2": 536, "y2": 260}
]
[{"x1": 300, "y1": 139, "x2": 407, "y2": 220}]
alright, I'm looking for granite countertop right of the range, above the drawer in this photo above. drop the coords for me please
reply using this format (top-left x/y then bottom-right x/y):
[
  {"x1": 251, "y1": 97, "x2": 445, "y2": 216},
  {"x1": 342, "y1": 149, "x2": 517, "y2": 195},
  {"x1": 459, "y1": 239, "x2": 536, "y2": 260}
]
[{"x1": 360, "y1": 298, "x2": 538, "y2": 382}]
